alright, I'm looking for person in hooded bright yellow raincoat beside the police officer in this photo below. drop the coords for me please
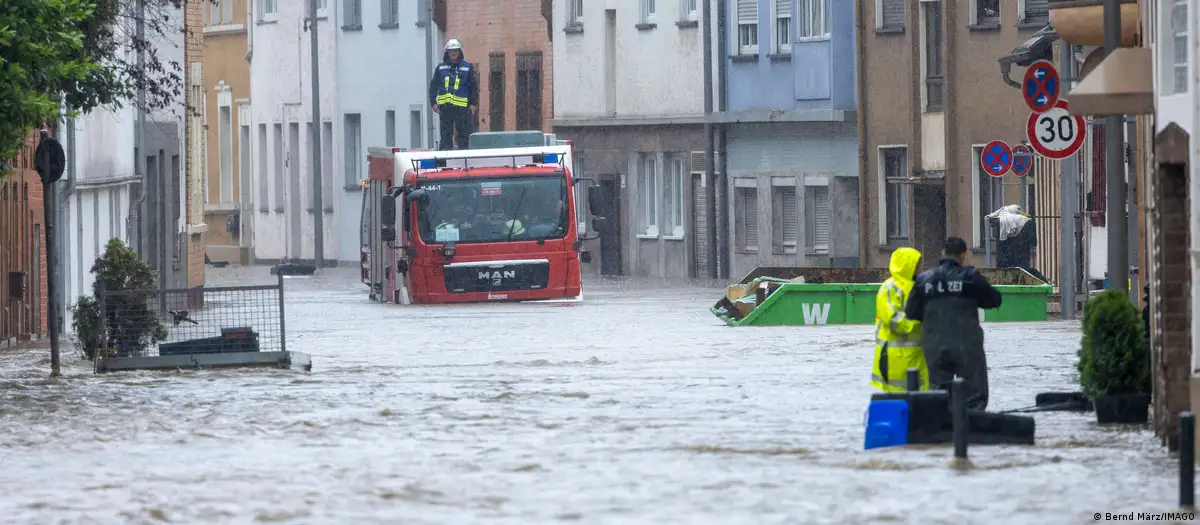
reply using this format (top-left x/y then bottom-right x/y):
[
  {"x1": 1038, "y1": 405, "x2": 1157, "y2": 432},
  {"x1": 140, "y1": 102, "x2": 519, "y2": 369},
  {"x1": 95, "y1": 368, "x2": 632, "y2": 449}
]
[{"x1": 871, "y1": 248, "x2": 929, "y2": 392}]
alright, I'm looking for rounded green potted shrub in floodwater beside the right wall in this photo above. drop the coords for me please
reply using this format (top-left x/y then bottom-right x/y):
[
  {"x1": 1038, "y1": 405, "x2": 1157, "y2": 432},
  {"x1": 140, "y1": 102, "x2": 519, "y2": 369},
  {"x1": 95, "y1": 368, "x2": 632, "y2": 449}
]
[{"x1": 1078, "y1": 290, "x2": 1151, "y2": 423}]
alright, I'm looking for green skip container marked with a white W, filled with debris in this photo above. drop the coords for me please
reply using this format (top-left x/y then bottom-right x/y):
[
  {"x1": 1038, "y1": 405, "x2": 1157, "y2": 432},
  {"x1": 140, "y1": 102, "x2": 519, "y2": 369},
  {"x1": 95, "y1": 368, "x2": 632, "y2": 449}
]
[{"x1": 710, "y1": 267, "x2": 1054, "y2": 326}]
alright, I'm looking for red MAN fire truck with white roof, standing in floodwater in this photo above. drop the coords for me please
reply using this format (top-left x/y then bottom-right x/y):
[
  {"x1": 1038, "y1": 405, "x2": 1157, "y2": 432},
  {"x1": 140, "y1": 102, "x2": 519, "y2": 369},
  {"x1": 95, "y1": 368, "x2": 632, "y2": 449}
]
[{"x1": 352, "y1": 132, "x2": 604, "y2": 304}]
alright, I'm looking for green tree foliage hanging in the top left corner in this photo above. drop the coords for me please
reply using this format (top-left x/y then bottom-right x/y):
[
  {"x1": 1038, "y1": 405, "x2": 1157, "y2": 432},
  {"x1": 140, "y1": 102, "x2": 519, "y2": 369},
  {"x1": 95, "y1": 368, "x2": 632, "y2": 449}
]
[{"x1": 0, "y1": 0, "x2": 192, "y2": 176}]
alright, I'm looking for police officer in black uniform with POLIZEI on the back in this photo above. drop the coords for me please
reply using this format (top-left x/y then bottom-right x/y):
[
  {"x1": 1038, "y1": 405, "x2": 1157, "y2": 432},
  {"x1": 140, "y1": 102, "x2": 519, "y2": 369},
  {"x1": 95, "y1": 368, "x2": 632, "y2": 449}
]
[{"x1": 905, "y1": 237, "x2": 1001, "y2": 410}]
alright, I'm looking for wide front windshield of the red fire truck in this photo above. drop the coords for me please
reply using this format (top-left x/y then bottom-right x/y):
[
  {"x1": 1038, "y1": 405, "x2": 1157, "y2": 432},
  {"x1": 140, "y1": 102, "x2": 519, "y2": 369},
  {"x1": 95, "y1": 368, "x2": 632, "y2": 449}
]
[{"x1": 416, "y1": 174, "x2": 570, "y2": 243}]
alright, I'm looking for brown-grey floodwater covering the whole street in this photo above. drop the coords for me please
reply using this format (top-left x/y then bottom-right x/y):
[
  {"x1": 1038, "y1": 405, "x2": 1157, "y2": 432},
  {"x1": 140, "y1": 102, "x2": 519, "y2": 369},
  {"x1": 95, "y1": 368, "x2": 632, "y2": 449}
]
[{"x1": 0, "y1": 267, "x2": 1177, "y2": 525}]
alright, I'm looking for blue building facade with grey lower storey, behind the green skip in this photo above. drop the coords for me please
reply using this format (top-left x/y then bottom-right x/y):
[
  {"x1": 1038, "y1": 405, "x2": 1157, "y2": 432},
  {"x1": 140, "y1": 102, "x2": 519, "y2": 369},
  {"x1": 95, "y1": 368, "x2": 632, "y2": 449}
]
[{"x1": 718, "y1": 0, "x2": 859, "y2": 276}]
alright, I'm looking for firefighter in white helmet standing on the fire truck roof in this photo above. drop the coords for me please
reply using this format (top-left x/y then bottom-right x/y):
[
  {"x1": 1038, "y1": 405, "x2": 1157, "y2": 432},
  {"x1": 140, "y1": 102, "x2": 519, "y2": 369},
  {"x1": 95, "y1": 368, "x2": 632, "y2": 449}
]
[{"x1": 430, "y1": 38, "x2": 479, "y2": 150}]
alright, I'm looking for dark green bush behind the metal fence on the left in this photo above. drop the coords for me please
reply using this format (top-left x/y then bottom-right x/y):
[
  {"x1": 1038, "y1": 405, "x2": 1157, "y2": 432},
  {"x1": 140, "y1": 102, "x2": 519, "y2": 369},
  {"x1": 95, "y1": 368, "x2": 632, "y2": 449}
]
[{"x1": 71, "y1": 239, "x2": 167, "y2": 360}]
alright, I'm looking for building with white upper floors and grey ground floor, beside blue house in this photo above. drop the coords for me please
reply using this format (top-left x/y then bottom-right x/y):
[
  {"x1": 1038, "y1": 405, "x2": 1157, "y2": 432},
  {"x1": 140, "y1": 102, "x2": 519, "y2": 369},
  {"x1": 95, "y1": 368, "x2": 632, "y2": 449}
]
[{"x1": 551, "y1": 0, "x2": 721, "y2": 278}]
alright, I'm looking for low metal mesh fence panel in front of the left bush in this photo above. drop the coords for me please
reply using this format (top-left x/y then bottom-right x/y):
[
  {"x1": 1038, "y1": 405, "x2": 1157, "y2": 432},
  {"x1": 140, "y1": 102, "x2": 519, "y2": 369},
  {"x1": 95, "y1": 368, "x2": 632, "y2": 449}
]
[{"x1": 100, "y1": 276, "x2": 287, "y2": 357}]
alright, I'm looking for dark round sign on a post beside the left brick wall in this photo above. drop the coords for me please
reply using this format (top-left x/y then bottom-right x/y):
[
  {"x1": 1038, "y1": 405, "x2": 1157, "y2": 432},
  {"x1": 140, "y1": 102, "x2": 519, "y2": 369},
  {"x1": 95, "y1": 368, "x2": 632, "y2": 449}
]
[{"x1": 34, "y1": 129, "x2": 67, "y2": 378}]
